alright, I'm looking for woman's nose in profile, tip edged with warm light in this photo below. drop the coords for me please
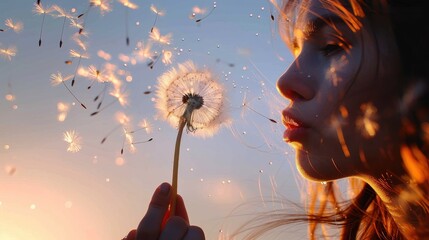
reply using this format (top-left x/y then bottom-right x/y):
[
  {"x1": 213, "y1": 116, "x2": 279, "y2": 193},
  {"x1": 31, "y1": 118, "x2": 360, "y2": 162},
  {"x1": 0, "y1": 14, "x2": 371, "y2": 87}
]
[{"x1": 277, "y1": 60, "x2": 316, "y2": 101}]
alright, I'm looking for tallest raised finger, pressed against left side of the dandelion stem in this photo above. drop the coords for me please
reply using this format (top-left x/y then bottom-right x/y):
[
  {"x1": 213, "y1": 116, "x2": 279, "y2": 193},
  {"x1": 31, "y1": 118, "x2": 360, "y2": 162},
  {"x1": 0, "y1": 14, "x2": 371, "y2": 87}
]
[{"x1": 136, "y1": 183, "x2": 171, "y2": 240}]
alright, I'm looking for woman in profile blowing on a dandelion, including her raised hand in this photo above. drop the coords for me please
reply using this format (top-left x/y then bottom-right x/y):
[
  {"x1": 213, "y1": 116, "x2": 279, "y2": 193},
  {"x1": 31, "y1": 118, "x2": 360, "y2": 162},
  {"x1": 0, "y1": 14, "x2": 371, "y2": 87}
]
[{"x1": 122, "y1": 0, "x2": 429, "y2": 240}]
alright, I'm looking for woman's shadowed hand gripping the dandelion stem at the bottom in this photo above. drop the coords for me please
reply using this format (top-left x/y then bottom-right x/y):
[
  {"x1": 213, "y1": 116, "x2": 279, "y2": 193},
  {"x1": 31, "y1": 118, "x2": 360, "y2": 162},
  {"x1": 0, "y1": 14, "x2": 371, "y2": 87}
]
[{"x1": 123, "y1": 183, "x2": 205, "y2": 240}]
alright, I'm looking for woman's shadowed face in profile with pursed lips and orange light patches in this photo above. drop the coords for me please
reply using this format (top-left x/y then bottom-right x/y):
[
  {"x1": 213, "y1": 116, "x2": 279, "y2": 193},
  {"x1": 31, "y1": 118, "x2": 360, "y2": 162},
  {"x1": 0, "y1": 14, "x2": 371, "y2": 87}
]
[{"x1": 277, "y1": 0, "x2": 400, "y2": 181}]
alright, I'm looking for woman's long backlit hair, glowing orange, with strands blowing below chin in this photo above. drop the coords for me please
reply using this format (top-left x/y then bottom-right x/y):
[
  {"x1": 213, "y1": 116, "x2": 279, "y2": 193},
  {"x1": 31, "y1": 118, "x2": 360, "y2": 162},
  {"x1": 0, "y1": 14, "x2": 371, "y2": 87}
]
[{"x1": 231, "y1": 0, "x2": 429, "y2": 240}]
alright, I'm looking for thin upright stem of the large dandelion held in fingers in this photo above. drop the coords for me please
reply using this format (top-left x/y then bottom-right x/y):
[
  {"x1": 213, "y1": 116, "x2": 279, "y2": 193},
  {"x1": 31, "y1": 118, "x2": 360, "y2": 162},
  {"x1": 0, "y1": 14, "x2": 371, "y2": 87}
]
[{"x1": 170, "y1": 117, "x2": 186, "y2": 217}]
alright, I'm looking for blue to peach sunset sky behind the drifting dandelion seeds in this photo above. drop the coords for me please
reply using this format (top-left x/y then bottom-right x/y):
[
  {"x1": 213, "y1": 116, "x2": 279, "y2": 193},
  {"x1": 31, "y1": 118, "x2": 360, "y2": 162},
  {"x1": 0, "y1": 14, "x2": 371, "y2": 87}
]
[{"x1": 0, "y1": 0, "x2": 305, "y2": 240}]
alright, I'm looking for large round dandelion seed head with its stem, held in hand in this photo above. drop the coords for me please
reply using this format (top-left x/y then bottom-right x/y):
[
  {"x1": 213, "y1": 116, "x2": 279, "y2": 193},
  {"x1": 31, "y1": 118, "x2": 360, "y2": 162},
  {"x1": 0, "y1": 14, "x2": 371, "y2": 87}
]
[{"x1": 156, "y1": 61, "x2": 229, "y2": 216}]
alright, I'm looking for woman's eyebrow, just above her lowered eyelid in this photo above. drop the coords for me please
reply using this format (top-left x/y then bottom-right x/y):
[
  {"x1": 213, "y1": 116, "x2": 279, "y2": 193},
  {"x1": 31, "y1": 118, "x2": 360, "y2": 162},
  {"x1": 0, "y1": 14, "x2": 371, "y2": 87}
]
[{"x1": 302, "y1": 14, "x2": 345, "y2": 39}]
